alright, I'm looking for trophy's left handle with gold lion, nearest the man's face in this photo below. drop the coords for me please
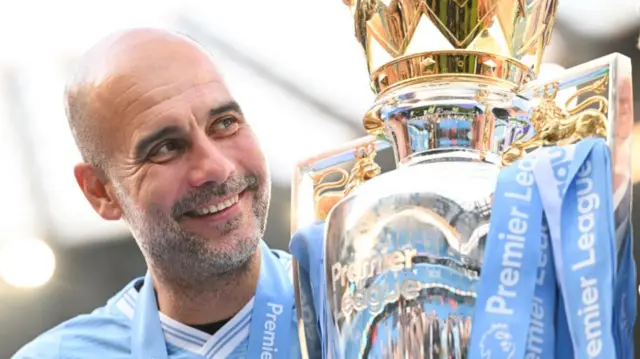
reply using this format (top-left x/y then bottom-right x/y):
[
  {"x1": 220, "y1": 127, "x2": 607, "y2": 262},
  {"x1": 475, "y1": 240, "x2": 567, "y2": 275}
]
[{"x1": 291, "y1": 136, "x2": 391, "y2": 359}]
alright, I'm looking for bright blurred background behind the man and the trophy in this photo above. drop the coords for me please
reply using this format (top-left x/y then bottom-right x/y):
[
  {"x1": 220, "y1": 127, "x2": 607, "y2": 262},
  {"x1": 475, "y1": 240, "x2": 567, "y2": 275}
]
[{"x1": 0, "y1": 0, "x2": 640, "y2": 359}]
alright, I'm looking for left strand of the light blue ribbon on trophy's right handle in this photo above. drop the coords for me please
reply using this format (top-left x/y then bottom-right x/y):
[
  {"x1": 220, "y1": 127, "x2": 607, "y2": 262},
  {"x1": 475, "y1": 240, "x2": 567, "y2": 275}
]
[{"x1": 469, "y1": 158, "x2": 552, "y2": 359}]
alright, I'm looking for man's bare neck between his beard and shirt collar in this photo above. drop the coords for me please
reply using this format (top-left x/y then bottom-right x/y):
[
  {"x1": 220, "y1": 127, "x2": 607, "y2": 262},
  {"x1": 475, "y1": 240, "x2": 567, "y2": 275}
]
[{"x1": 153, "y1": 248, "x2": 261, "y2": 325}]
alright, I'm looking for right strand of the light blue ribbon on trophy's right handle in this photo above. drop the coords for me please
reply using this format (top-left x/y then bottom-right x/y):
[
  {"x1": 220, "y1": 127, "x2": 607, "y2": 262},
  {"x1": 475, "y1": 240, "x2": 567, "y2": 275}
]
[{"x1": 535, "y1": 138, "x2": 617, "y2": 358}]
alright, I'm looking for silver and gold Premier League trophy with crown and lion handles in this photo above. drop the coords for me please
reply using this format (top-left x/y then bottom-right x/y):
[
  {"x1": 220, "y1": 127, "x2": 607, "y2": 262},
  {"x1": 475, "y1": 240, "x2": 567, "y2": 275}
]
[{"x1": 292, "y1": 0, "x2": 635, "y2": 359}]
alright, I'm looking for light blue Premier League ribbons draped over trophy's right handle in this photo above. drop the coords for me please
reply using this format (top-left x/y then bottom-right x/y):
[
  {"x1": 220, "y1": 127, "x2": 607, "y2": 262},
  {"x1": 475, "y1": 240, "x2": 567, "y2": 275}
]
[{"x1": 469, "y1": 138, "x2": 636, "y2": 359}]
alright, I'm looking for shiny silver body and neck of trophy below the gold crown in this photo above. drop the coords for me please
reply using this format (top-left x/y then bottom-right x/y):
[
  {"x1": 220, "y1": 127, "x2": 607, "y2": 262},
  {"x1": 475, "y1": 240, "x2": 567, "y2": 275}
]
[{"x1": 325, "y1": 86, "x2": 527, "y2": 358}]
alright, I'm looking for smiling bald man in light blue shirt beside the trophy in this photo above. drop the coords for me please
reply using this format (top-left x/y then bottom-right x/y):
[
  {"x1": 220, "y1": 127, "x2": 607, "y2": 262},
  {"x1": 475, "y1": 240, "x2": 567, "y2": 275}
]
[{"x1": 14, "y1": 29, "x2": 300, "y2": 359}]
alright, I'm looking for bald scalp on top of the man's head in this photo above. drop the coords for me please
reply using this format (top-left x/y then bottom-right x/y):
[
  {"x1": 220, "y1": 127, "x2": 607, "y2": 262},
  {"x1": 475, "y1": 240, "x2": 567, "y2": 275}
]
[{"x1": 65, "y1": 28, "x2": 215, "y2": 170}]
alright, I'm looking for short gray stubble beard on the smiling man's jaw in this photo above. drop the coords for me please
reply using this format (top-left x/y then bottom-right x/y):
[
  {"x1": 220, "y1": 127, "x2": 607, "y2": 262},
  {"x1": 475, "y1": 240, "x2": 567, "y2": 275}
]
[{"x1": 116, "y1": 177, "x2": 271, "y2": 295}]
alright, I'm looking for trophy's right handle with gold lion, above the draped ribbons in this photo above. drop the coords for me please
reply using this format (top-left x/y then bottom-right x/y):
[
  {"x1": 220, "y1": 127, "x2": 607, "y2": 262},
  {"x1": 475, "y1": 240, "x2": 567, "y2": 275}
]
[{"x1": 516, "y1": 53, "x2": 634, "y2": 254}]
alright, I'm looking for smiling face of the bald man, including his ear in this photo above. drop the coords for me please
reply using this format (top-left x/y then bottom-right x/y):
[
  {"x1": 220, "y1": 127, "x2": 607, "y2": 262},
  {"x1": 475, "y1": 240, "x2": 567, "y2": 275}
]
[{"x1": 70, "y1": 30, "x2": 270, "y2": 284}]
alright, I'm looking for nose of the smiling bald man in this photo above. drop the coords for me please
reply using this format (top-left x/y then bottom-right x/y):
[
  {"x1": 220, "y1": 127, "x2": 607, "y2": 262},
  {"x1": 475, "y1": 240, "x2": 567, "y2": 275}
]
[{"x1": 189, "y1": 134, "x2": 235, "y2": 187}]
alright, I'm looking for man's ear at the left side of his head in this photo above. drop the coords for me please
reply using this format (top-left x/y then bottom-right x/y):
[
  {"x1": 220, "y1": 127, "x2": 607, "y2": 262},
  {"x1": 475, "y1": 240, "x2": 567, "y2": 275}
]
[{"x1": 73, "y1": 163, "x2": 122, "y2": 221}]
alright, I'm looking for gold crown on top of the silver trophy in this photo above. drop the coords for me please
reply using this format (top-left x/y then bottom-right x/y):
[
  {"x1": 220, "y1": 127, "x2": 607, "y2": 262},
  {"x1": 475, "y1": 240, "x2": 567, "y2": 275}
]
[{"x1": 344, "y1": 0, "x2": 557, "y2": 96}]
